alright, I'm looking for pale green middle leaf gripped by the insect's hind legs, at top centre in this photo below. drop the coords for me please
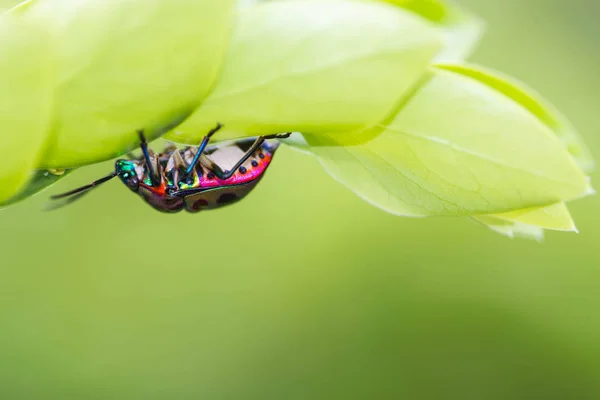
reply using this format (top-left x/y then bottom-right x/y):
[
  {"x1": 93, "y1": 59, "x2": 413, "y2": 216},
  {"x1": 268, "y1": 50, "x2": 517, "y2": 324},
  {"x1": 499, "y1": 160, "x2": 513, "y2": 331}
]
[{"x1": 167, "y1": 0, "x2": 440, "y2": 143}]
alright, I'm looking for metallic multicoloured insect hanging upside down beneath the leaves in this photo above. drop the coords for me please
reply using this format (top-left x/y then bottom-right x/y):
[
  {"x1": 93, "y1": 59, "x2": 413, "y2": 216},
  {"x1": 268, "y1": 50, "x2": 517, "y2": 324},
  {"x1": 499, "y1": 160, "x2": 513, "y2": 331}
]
[{"x1": 51, "y1": 124, "x2": 291, "y2": 213}]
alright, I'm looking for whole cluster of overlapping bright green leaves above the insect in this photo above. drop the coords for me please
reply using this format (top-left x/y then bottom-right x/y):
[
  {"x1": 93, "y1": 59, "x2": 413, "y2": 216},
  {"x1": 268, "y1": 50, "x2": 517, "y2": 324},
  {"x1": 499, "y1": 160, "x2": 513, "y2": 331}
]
[{"x1": 0, "y1": 0, "x2": 594, "y2": 239}]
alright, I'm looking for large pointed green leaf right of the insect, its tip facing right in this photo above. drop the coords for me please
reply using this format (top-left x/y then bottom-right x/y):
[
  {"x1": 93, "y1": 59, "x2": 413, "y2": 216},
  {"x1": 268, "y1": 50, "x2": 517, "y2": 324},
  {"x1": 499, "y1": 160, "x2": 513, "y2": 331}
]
[{"x1": 306, "y1": 68, "x2": 591, "y2": 216}]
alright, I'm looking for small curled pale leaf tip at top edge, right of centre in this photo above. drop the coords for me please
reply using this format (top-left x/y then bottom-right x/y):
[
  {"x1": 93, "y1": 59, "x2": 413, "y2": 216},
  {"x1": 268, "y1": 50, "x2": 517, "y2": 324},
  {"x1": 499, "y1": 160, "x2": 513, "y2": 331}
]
[{"x1": 368, "y1": 0, "x2": 485, "y2": 62}]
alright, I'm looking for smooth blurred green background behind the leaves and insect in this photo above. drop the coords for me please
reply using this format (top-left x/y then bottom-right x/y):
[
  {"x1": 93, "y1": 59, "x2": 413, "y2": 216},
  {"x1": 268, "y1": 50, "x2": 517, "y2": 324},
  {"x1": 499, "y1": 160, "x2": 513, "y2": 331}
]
[{"x1": 0, "y1": 0, "x2": 600, "y2": 400}]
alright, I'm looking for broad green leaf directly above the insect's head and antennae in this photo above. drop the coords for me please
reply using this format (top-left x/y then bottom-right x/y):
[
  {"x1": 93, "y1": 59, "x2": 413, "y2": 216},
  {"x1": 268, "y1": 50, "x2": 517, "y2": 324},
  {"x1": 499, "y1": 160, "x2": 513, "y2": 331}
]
[{"x1": 11, "y1": 0, "x2": 235, "y2": 168}]
